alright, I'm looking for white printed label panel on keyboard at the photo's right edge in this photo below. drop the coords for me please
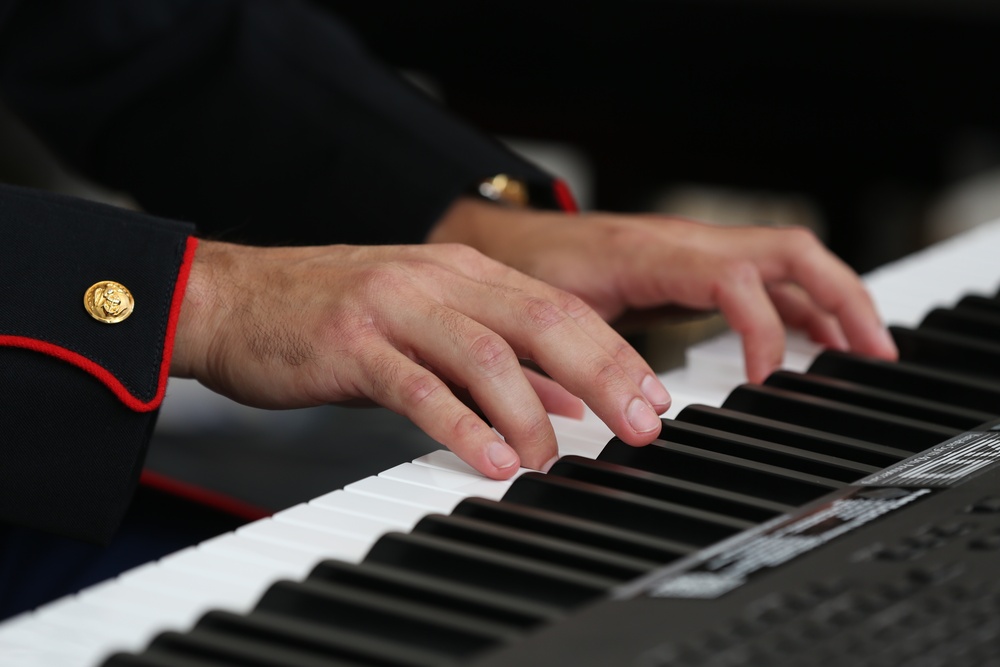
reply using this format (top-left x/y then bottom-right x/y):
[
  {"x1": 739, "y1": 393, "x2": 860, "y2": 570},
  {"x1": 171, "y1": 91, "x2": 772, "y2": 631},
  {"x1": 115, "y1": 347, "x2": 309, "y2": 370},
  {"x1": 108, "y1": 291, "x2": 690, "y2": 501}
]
[{"x1": 857, "y1": 431, "x2": 1000, "y2": 489}]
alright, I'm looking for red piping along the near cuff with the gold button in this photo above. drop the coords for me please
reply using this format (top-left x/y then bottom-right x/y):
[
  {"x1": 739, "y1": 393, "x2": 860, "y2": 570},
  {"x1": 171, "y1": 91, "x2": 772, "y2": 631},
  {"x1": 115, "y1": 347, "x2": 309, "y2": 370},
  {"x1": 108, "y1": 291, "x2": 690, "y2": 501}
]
[{"x1": 0, "y1": 236, "x2": 198, "y2": 412}]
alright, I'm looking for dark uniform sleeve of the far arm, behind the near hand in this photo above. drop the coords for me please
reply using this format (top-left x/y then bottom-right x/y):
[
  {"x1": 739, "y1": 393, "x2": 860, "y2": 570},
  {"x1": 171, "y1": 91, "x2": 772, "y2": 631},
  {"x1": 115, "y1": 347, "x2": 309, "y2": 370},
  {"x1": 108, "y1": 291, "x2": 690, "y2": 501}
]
[{"x1": 0, "y1": 0, "x2": 555, "y2": 244}]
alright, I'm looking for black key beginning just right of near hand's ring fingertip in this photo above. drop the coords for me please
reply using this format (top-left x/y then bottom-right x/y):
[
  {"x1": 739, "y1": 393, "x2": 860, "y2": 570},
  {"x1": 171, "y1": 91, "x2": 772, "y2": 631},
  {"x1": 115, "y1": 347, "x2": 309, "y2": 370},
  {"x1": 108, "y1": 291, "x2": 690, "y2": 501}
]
[{"x1": 549, "y1": 456, "x2": 795, "y2": 522}]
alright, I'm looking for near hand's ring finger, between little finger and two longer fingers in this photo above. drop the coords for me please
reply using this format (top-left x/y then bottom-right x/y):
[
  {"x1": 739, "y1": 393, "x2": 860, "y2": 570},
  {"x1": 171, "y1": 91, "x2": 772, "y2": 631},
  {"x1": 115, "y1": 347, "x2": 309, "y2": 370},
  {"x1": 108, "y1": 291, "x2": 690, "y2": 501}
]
[{"x1": 393, "y1": 302, "x2": 558, "y2": 470}]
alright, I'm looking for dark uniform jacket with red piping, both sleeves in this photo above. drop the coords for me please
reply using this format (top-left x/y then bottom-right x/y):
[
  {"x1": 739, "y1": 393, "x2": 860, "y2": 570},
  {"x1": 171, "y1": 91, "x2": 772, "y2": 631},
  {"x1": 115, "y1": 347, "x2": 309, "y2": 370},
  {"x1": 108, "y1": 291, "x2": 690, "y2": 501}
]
[{"x1": 0, "y1": 0, "x2": 569, "y2": 541}]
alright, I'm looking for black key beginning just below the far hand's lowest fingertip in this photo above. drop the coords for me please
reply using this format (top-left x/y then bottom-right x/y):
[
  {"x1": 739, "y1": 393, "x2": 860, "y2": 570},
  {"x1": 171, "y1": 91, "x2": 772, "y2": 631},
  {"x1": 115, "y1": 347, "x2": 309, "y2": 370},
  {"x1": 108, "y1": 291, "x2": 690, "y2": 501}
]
[{"x1": 722, "y1": 385, "x2": 959, "y2": 452}]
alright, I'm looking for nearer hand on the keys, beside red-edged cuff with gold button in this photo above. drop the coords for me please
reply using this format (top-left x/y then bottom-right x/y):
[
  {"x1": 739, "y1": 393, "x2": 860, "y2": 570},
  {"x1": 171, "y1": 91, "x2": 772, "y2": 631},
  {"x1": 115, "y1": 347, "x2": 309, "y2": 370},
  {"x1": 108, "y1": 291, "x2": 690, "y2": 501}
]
[{"x1": 171, "y1": 241, "x2": 670, "y2": 479}]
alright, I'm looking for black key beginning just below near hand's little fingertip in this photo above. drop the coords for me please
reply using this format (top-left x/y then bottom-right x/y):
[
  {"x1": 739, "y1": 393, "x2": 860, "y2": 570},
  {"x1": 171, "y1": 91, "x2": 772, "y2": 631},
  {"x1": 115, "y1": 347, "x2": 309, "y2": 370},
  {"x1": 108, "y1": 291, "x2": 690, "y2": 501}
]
[{"x1": 504, "y1": 472, "x2": 754, "y2": 546}]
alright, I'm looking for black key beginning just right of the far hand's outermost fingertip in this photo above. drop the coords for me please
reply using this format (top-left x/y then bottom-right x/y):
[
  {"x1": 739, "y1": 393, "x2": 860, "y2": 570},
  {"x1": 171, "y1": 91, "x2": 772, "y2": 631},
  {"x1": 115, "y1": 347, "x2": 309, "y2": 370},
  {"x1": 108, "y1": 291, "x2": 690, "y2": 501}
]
[{"x1": 889, "y1": 327, "x2": 1000, "y2": 383}]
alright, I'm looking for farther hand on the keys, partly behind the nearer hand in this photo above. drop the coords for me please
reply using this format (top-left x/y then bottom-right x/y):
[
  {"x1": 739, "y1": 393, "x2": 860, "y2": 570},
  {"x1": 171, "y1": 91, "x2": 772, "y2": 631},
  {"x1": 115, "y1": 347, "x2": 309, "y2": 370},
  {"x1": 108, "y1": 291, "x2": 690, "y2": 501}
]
[{"x1": 428, "y1": 199, "x2": 897, "y2": 382}]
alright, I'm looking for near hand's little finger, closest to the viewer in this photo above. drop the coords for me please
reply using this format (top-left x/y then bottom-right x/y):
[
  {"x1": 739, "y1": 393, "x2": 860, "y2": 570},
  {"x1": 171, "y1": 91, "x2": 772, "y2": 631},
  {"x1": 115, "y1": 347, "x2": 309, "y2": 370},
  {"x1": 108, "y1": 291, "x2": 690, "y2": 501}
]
[{"x1": 358, "y1": 345, "x2": 520, "y2": 479}]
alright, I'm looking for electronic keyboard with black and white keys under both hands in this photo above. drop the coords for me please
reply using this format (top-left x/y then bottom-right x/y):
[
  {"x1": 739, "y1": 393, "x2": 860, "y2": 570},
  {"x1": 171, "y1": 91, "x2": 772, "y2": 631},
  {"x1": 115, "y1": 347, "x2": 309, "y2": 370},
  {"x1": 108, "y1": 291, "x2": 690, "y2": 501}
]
[{"x1": 0, "y1": 222, "x2": 1000, "y2": 667}]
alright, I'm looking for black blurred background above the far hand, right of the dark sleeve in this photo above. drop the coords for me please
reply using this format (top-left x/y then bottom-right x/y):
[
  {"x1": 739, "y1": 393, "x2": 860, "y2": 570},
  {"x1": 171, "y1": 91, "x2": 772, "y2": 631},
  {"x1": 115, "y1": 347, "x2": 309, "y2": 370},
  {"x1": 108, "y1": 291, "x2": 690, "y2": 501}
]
[{"x1": 324, "y1": 0, "x2": 1000, "y2": 271}]
